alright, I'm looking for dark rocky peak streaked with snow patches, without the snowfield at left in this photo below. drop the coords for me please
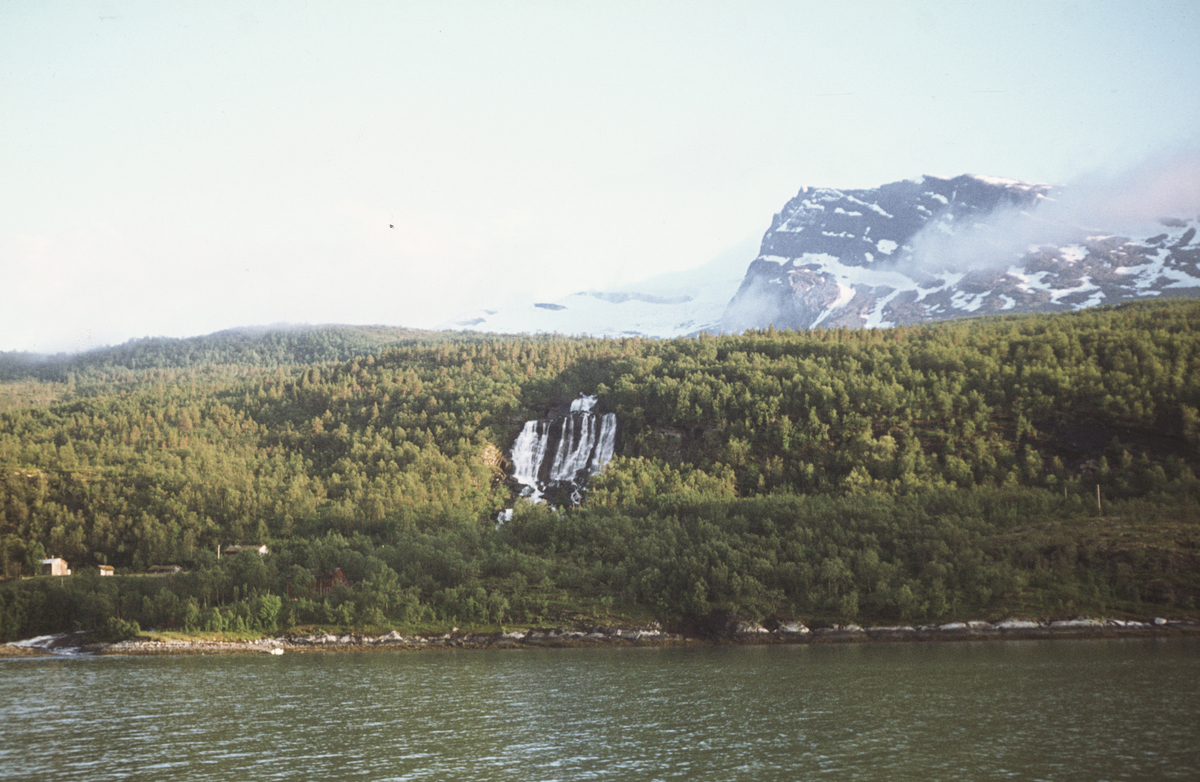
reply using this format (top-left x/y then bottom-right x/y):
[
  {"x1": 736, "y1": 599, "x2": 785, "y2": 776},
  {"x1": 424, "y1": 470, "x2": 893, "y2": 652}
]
[{"x1": 721, "y1": 175, "x2": 1200, "y2": 331}]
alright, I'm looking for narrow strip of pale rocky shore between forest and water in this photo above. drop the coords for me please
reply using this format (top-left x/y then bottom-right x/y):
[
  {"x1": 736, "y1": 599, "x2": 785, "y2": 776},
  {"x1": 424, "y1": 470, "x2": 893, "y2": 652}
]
[{"x1": 9, "y1": 618, "x2": 1200, "y2": 656}]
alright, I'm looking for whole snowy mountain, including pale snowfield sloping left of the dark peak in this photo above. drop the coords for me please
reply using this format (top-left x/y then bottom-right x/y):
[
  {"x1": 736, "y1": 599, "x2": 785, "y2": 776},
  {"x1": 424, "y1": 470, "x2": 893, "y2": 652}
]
[{"x1": 448, "y1": 174, "x2": 1200, "y2": 337}]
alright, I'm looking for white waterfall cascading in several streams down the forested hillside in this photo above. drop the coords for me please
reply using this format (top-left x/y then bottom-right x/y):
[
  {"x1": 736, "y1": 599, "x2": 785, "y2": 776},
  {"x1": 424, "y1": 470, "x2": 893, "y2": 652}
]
[{"x1": 512, "y1": 395, "x2": 617, "y2": 503}]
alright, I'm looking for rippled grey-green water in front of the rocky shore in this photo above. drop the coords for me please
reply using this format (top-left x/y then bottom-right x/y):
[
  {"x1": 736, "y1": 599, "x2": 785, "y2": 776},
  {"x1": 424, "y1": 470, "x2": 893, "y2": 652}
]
[{"x1": 0, "y1": 639, "x2": 1200, "y2": 782}]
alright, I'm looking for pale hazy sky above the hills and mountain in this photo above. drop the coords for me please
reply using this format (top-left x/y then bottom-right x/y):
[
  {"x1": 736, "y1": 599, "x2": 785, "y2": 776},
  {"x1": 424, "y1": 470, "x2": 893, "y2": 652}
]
[{"x1": 0, "y1": 0, "x2": 1200, "y2": 353}]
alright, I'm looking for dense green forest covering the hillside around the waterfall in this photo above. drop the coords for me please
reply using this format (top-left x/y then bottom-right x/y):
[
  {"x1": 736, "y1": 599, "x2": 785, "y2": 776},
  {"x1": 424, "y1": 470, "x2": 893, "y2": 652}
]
[{"x1": 0, "y1": 300, "x2": 1200, "y2": 639}]
